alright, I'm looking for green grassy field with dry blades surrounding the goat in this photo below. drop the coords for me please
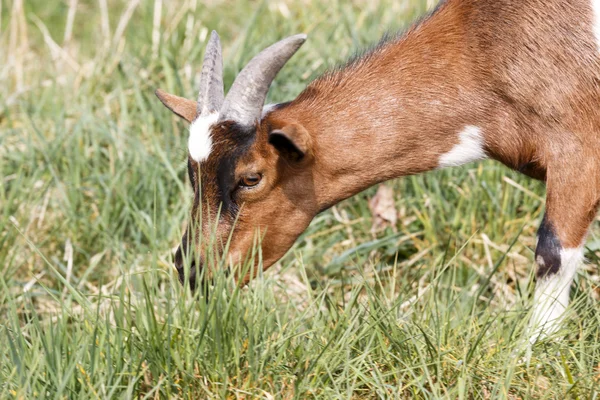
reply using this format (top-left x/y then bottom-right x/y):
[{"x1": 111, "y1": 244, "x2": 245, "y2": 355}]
[{"x1": 0, "y1": 0, "x2": 600, "y2": 399}]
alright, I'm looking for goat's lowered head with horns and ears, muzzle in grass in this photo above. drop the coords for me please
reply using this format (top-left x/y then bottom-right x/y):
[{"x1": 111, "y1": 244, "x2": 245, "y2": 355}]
[{"x1": 156, "y1": 32, "x2": 318, "y2": 288}]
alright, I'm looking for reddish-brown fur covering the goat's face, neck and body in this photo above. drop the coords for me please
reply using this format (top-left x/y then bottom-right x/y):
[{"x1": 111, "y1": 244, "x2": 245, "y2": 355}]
[{"x1": 158, "y1": 0, "x2": 600, "y2": 280}]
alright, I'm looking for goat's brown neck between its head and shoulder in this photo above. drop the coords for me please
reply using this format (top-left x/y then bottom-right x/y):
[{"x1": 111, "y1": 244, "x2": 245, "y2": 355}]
[{"x1": 285, "y1": 1, "x2": 486, "y2": 208}]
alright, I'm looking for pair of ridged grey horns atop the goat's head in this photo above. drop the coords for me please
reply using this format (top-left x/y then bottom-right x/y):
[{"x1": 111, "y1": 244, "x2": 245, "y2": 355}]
[{"x1": 196, "y1": 31, "x2": 306, "y2": 125}]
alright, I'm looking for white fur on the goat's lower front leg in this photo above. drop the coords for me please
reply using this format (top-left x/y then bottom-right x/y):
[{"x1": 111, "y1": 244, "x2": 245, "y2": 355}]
[{"x1": 529, "y1": 247, "x2": 583, "y2": 343}]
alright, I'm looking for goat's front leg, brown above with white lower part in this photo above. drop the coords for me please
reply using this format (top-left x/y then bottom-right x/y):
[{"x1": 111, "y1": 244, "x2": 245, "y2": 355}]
[{"x1": 529, "y1": 167, "x2": 599, "y2": 343}]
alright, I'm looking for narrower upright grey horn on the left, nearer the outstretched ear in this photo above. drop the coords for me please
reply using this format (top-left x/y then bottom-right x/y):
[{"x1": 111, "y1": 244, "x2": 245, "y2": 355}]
[{"x1": 196, "y1": 31, "x2": 224, "y2": 115}]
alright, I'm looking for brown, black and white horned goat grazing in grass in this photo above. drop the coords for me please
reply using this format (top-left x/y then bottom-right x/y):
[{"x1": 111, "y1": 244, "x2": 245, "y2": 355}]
[{"x1": 156, "y1": 0, "x2": 600, "y2": 340}]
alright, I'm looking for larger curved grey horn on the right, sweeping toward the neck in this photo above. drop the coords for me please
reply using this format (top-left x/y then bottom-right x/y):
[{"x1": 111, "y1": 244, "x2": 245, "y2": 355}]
[{"x1": 219, "y1": 34, "x2": 306, "y2": 125}]
